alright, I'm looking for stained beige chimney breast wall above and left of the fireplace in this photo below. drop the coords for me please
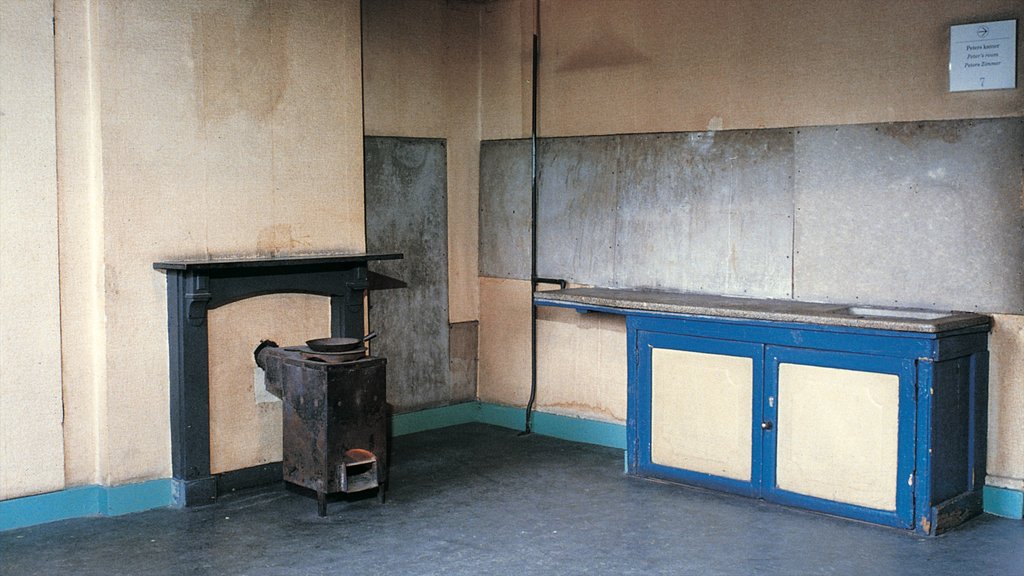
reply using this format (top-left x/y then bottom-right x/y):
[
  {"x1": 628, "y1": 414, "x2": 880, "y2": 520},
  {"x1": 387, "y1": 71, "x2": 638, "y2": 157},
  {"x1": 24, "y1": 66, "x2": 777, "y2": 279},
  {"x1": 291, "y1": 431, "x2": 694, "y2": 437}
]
[{"x1": 92, "y1": 0, "x2": 364, "y2": 484}]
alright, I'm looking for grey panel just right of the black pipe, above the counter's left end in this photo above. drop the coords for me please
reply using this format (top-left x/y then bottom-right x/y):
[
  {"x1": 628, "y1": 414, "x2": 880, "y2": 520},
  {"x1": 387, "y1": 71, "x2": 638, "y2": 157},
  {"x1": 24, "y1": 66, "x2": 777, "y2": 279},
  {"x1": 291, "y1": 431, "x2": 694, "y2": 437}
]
[{"x1": 537, "y1": 136, "x2": 621, "y2": 286}]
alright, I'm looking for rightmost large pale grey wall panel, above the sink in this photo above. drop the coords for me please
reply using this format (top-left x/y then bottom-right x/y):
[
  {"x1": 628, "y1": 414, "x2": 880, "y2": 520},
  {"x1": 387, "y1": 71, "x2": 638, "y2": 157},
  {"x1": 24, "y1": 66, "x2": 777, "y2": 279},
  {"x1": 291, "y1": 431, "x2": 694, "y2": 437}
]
[{"x1": 794, "y1": 119, "x2": 1024, "y2": 314}]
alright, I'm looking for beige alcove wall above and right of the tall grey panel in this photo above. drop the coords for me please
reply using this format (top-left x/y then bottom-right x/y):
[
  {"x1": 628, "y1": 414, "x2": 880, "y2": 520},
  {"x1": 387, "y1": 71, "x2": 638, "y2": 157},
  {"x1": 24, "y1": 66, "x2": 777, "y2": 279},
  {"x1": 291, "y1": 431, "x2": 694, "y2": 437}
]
[{"x1": 362, "y1": 0, "x2": 481, "y2": 323}]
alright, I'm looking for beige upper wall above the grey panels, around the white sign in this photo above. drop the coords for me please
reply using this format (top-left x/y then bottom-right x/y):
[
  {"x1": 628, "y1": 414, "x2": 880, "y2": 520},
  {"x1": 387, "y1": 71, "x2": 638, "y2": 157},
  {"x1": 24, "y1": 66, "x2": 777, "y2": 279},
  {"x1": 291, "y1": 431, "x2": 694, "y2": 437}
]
[{"x1": 540, "y1": 0, "x2": 1024, "y2": 136}]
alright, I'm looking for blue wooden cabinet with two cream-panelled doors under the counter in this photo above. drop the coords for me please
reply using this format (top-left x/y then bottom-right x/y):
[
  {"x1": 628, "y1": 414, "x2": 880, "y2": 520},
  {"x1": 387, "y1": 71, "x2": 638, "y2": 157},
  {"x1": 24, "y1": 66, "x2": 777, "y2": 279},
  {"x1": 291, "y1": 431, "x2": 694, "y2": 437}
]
[{"x1": 535, "y1": 291, "x2": 989, "y2": 535}]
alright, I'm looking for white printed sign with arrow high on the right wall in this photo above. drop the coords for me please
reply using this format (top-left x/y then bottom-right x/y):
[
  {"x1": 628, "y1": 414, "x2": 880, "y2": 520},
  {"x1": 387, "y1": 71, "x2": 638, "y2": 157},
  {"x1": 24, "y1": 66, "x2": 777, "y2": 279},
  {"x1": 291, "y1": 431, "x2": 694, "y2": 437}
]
[{"x1": 949, "y1": 20, "x2": 1017, "y2": 92}]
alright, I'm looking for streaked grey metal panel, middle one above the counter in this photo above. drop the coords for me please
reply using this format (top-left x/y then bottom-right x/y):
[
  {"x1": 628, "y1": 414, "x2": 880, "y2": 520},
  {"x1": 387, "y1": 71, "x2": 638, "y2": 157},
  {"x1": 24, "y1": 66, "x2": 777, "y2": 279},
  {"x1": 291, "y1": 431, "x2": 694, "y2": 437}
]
[{"x1": 613, "y1": 130, "x2": 793, "y2": 297}]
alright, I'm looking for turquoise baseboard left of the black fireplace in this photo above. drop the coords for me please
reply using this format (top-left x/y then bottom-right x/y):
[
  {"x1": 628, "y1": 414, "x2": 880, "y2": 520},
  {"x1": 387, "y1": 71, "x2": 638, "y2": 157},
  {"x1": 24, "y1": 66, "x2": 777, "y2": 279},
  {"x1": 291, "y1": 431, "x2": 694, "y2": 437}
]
[{"x1": 0, "y1": 479, "x2": 172, "y2": 530}]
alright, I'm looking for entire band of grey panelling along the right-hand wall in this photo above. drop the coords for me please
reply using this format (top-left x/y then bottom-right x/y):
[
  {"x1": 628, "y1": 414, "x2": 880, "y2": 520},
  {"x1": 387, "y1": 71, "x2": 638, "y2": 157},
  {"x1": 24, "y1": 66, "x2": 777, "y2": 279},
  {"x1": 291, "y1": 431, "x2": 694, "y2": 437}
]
[{"x1": 480, "y1": 119, "x2": 1024, "y2": 314}]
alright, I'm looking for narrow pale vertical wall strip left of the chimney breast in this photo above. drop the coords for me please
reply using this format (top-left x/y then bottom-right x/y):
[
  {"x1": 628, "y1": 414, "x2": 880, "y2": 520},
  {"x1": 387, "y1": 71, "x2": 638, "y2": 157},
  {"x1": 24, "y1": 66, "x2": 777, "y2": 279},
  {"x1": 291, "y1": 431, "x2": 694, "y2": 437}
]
[{"x1": 53, "y1": 0, "x2": 106, "y2": 485}]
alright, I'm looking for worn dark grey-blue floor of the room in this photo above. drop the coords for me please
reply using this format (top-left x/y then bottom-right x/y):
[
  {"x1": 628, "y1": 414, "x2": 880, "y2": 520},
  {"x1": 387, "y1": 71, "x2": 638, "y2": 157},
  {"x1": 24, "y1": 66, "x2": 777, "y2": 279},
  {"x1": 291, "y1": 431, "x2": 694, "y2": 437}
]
[{"x1": 0, "y1": 424, "x2": 1024, "y2": 576}]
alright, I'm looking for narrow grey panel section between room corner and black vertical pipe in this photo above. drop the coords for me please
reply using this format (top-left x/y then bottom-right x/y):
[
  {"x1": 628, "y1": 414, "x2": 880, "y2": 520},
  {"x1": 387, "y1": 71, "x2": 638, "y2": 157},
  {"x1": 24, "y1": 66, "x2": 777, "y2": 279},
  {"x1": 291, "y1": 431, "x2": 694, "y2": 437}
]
[{"x1": 479, "y1": 139, "x2": 532, "y2": 280}]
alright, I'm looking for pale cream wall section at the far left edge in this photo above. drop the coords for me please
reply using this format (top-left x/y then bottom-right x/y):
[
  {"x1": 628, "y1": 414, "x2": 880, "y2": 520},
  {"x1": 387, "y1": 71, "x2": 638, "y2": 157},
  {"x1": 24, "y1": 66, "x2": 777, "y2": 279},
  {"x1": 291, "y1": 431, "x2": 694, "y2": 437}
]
[{"x1": 0, "y1": 0, "x2": 65, "y2": 499}]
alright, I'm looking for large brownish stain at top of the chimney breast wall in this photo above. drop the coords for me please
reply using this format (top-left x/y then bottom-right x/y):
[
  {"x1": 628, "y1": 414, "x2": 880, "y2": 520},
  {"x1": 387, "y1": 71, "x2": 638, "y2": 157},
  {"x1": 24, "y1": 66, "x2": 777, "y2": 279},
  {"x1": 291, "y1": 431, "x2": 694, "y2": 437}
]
[{"x1": 191, "y1": 0, "x2": 289, "y2": 125}]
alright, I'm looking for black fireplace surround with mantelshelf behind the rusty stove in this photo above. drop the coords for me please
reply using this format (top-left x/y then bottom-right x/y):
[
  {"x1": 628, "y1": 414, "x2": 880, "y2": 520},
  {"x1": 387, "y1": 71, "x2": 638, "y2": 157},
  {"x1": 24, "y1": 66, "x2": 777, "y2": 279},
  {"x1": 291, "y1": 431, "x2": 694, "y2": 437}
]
[{"x1": 153, "y1": 253, "x2": 402, "y2": 506}]
